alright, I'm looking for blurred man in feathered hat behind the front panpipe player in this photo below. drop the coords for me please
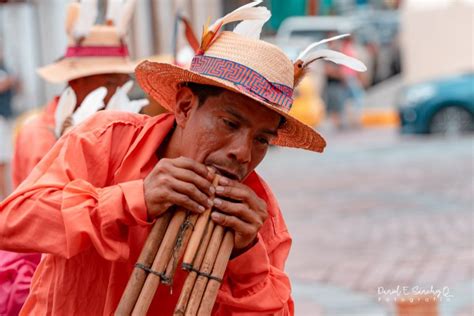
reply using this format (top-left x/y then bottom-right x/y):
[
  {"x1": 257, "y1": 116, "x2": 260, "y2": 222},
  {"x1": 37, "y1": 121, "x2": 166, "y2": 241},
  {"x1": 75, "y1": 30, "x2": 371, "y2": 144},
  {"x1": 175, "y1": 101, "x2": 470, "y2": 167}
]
[{"x1": 0, "y1": 3, "x2": 143, "y2": 315}]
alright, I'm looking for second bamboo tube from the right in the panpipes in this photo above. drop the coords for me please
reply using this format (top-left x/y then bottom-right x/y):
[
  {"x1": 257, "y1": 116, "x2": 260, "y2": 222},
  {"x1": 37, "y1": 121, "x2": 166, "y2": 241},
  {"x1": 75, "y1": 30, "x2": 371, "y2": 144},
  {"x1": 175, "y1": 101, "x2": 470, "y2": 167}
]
[{"x1": 185, "y1": 225, "x2": 224, "y2": 316}]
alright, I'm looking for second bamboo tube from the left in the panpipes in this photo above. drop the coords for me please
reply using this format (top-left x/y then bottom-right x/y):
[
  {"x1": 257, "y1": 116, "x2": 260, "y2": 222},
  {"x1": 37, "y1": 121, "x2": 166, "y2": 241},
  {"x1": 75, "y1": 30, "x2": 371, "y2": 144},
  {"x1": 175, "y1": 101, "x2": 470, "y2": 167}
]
[{"x1": 132, "y1": 209, "x2": 186, "y2": 316}]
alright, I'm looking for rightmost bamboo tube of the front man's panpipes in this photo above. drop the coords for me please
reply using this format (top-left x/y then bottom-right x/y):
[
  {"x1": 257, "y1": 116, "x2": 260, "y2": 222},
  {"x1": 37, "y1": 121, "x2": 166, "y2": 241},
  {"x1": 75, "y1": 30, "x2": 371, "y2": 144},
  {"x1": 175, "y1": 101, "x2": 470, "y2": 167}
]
[{"x1": 197, "y1": 231, "x2": 234, "y2": 316}]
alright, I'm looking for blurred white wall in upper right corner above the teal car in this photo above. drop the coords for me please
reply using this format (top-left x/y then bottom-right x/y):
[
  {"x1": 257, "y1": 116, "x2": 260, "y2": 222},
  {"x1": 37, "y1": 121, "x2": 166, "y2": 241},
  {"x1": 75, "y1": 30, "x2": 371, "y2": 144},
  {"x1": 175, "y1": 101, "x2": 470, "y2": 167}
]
[{"x1": 401, "y1": 0, "x2": 474, "y2": 84}]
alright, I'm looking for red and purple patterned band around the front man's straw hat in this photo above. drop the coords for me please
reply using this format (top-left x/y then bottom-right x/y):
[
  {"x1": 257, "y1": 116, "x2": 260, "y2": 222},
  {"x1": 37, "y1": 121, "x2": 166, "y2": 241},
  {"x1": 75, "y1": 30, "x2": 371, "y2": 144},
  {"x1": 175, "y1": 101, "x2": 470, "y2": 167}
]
[{"x1": 191, "y1": 55, "x2": 293, "y2": 112}]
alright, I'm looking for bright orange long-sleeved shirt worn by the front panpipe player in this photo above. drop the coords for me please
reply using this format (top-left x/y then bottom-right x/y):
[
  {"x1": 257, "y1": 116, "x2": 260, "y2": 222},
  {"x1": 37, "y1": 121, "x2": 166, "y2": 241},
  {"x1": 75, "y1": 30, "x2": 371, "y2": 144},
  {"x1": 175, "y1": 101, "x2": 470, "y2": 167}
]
[{"x1": 0, "y1": 112, "x2": 293, "y2": 315}]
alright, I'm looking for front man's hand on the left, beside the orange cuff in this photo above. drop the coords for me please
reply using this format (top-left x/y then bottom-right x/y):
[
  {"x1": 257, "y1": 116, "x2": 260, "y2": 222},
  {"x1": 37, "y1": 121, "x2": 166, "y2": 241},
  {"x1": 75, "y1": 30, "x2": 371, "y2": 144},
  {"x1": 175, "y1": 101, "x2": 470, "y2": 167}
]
[{"x1": 144, "y1": 157, "x2": 215, "y2": 219}]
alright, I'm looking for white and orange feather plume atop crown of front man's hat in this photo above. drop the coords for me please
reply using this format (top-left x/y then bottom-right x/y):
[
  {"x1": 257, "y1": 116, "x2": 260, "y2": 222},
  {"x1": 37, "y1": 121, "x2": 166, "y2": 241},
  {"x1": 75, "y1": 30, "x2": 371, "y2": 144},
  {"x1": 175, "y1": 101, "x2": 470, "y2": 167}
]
[{"x1": 199, "y1": 1, "x2": 271, "y2": 54}]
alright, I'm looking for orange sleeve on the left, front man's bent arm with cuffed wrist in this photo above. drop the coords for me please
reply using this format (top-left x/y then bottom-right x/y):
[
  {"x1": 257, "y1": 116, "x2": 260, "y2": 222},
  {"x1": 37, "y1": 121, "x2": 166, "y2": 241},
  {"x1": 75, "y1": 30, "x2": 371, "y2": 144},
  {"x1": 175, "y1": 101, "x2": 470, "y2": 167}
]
[{"x1": 0, "y1": 113, "x2": 148, "y2": 260}]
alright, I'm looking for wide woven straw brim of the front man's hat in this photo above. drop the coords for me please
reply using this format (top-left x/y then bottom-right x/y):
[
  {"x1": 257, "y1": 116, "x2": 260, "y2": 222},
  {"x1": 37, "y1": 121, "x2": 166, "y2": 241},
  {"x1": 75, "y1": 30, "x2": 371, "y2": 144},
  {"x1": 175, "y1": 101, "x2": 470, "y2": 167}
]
[{"x1": 135, "y1": 61, "x2": 326, "y2": 152}]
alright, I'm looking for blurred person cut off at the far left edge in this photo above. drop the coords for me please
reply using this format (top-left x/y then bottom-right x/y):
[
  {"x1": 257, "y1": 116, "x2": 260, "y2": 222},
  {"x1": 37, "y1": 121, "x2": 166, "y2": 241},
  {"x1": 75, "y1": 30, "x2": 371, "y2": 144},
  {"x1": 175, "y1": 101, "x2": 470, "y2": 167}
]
[{"x1": 0, "y1": 51, "x2": 16, "y2": 200}]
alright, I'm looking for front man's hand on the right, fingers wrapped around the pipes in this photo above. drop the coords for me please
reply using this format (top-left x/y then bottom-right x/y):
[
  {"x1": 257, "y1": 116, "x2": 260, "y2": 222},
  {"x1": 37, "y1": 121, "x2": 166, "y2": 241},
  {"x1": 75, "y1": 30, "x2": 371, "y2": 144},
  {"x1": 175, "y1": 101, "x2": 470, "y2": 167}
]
[{"x1": 211, "y1": 177, "x2": 268, "y2": 255}]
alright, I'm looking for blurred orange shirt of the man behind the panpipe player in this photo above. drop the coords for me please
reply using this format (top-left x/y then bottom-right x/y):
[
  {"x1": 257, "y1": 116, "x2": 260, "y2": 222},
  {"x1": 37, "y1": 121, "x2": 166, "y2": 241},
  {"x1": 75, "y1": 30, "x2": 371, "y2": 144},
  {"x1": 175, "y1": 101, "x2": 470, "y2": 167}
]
[{"x1": 12, "y1": 97, "x2": 59, "y2": 188}]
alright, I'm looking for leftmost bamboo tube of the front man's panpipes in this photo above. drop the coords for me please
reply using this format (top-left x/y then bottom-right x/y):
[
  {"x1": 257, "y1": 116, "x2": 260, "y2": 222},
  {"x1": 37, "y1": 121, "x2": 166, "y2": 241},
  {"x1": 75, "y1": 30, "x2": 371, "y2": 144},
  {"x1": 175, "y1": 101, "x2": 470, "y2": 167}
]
[{"x1": 115, "y1": 212, "x2": 172, "y2": 316}]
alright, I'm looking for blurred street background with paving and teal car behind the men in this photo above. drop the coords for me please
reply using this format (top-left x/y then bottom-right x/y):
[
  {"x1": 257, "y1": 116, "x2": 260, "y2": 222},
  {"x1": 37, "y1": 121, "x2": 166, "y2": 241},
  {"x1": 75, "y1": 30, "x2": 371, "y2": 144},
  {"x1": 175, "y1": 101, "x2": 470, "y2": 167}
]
[{"x1": 0, "y1": 0, "x2": 474, "y2": 315}]
